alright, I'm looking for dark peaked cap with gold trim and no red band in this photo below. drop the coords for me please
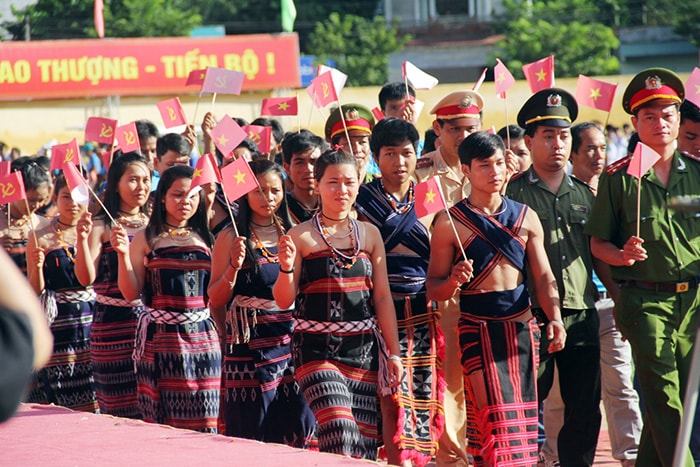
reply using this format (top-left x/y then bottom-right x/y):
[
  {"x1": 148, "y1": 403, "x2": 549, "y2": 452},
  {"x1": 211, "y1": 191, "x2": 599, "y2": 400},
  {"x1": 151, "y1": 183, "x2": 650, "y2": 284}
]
[{"x1": 518, "y1": 88, "x2": 578, "y2": 128}]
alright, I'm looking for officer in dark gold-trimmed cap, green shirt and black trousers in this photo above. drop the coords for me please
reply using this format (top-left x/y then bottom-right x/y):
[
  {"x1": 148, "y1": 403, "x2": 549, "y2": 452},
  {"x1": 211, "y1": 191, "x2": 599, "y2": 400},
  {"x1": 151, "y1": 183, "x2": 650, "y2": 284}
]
[{"x1": 506, "y1": 88, "x2": 607, "y2": 466}]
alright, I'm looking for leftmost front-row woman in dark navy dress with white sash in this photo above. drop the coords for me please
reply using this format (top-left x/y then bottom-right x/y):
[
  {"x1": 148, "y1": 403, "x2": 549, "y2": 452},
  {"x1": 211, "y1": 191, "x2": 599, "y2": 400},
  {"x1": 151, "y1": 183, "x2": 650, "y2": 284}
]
[{"x1": 27, "y1": 175, "x2": 98, "y2": 412}]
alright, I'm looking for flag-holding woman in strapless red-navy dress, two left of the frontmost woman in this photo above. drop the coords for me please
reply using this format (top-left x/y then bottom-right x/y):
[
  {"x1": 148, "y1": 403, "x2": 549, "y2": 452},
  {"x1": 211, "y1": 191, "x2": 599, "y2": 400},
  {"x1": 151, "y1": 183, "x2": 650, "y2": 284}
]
[{"x1": 111, "y1": 165, "x2": 221, "y2": 433}]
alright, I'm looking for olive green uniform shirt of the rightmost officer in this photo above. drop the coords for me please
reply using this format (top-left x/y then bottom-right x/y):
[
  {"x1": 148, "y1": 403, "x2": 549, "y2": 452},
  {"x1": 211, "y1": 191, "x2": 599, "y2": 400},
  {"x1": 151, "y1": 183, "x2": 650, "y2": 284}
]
[{"x1": 585, "y1": 152, "x2": 700, "y2": 282}]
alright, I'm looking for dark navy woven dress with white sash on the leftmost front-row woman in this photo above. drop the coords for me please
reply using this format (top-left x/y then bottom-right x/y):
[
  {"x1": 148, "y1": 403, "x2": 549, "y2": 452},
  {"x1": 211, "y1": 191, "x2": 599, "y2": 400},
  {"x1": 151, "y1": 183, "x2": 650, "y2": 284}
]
[{"x1": 27, "y1": 246, "x2": 98, "y2": 412}]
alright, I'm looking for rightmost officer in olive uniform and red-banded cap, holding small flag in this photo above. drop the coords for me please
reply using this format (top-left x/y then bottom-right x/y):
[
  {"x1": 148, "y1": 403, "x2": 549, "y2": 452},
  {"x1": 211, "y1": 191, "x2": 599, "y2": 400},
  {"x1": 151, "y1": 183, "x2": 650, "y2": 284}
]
[{"x1": 585, "y1": 68, "x2": 700, "y2": 467}]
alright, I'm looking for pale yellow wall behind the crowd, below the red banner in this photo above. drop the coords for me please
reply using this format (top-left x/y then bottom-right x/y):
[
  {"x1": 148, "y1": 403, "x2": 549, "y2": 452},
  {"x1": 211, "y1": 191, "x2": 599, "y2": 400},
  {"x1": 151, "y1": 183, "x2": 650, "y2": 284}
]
[{"x1": 0, "y1": 74, "x2": 688, "y2": 154}]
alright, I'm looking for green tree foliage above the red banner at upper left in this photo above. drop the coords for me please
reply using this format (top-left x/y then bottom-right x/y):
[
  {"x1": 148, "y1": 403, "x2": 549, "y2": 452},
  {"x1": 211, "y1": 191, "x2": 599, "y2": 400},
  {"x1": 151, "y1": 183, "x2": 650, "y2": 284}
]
[{"x1": 2, "y1": 0, "x2": 202, "y2": 40}]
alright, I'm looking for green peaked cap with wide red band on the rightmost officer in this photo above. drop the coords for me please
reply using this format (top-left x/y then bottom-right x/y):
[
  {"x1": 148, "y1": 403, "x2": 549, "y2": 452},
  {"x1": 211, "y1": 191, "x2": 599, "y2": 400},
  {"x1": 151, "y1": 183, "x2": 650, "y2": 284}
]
[{"x1": 622, "y1": 68, "x2": 685, "y2": 115}]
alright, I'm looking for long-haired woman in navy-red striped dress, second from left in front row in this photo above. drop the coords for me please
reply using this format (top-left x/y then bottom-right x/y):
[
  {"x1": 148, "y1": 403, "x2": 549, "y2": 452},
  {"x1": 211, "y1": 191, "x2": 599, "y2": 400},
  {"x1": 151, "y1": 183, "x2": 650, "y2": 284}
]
[{"x1": 75, "y1": 152, "x2": 151, "y2": 418}]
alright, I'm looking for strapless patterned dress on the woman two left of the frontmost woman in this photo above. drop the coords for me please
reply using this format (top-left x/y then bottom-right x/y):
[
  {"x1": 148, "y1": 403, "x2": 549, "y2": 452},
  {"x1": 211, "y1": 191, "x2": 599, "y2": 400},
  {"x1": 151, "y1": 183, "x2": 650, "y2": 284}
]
[{"x1": 134, "y1": 245, "x2": 221, "y2": 433}]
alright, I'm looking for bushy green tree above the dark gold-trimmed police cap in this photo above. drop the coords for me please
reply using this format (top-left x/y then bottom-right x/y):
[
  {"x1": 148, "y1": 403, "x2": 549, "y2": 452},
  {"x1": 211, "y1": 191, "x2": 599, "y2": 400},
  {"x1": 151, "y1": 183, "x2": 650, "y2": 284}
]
[{"x1": 496, "y1": 0, "x2": 620, "y2": 78}]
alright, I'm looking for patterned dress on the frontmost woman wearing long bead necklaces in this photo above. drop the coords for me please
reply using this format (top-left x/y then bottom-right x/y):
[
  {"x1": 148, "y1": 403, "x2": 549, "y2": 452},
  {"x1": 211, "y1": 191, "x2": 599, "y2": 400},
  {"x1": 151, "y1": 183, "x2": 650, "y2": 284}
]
[{"x1": 292, "y1": 250, "x2": 381, "y2": 460}]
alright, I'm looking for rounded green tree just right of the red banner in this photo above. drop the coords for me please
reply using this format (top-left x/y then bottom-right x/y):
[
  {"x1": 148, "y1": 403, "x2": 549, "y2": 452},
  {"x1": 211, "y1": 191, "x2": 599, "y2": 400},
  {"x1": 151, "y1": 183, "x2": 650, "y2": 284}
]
[{"x1": 306, "y1": 13, "x2": 410, "y2": 86}]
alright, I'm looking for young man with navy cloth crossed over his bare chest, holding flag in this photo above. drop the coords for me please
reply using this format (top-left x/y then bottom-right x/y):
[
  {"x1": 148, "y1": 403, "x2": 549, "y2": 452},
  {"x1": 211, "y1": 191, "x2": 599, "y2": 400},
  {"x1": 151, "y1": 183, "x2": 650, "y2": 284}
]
[{"x1": 427, "y1": 132, "x2": 566, "y2": 466}]
